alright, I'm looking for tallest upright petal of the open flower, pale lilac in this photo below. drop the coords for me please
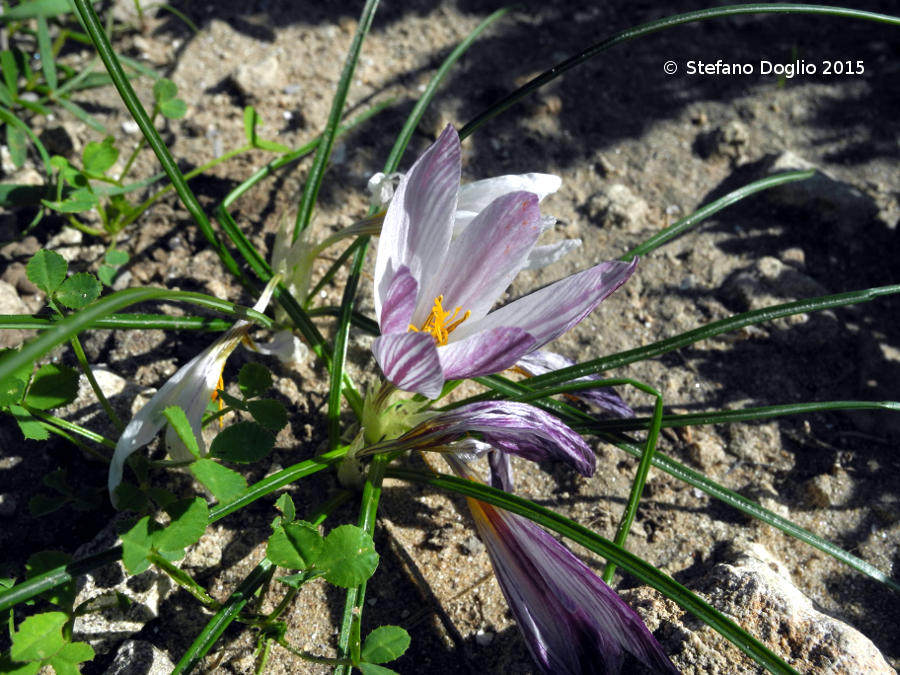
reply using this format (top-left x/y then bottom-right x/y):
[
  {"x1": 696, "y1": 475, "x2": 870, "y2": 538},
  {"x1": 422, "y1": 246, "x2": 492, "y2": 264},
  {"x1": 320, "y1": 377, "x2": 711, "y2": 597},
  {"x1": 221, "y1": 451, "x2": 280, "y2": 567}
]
[{"x1": 375, "y1": 125, "x2": 461, "y2": 318}]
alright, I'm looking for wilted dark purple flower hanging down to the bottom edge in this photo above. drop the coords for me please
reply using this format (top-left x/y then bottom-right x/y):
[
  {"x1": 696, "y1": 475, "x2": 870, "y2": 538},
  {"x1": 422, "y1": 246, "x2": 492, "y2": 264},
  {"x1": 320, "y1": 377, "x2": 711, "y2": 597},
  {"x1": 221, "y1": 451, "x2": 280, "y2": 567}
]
[{"x1": 468, "y1": 499, "x2": 678, "y2": 675}]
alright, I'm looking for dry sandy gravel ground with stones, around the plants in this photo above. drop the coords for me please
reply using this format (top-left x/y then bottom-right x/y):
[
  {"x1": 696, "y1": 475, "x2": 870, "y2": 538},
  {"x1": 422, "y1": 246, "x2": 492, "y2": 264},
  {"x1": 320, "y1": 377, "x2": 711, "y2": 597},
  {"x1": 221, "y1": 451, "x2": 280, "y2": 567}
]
[{"x1": 0, "y1": 0, "x2": 900, "y2": 673}]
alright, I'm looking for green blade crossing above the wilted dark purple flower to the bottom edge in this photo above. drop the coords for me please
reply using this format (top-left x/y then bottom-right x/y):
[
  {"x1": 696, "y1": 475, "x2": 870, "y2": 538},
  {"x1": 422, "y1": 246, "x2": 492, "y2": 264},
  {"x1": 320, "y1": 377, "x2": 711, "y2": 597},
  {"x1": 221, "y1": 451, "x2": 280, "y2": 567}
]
[{"x1": 387, "y1": 468, "x2": 797, "y2": 674}]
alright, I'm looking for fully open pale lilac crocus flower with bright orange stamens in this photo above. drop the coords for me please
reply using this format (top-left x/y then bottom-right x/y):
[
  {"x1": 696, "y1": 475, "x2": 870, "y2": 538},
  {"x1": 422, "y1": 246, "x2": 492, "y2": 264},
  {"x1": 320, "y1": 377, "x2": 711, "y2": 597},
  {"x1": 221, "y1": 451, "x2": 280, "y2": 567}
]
[{"x1": 372, "y1": 126, "x2": 637, "y2": 398}]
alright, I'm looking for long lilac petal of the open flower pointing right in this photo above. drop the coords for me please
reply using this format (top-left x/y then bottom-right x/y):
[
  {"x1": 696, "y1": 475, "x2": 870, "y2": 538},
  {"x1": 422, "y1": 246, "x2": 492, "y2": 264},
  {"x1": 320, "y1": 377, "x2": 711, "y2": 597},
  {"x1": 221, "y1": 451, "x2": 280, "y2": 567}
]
[{"x1": 453, "y1": 258, "x2": 637, "y2": 347}]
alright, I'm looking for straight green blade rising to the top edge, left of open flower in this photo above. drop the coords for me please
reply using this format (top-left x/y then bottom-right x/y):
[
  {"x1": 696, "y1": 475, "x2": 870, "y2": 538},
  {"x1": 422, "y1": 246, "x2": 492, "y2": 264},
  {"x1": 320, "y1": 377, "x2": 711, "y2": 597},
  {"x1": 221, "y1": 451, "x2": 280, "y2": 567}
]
[{"x1": 293, "y1": 0, "x2": 378, "y2": 240}]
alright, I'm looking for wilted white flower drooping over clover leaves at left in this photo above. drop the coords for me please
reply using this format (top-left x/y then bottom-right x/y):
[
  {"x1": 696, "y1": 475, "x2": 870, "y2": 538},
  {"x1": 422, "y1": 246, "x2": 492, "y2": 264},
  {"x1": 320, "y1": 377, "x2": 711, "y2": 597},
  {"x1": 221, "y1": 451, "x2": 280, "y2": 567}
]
[{"x1": 108, "y1": 278, "x2": 277, "y2": 504}]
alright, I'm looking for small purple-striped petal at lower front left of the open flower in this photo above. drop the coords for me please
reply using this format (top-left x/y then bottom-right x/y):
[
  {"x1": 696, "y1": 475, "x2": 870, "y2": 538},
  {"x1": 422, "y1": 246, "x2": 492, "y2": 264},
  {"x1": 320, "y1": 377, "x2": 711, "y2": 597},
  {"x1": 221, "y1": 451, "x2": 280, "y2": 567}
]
[{"x1": 372, "y1": 333, "x2": 444, "y2": 398}]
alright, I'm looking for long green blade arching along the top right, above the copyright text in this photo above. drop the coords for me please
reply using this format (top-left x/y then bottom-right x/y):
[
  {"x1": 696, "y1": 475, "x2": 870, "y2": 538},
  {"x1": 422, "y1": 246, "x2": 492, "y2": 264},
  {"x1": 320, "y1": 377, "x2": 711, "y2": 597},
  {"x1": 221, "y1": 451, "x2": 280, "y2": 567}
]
[{"x1": 459, "y1": 3, "x2": 900, "y2": 138}]
